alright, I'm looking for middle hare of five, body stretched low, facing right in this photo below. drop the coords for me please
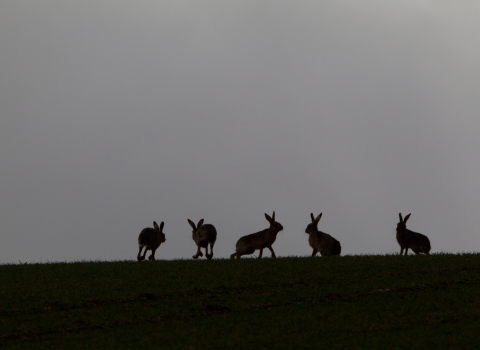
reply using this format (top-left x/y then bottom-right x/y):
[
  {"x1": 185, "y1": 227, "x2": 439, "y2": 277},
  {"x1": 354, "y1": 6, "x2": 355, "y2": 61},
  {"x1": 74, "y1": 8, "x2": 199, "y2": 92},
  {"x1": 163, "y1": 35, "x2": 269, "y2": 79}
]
[{"x1": 230, "y1": 212, "x2": 283, "y2": 259}]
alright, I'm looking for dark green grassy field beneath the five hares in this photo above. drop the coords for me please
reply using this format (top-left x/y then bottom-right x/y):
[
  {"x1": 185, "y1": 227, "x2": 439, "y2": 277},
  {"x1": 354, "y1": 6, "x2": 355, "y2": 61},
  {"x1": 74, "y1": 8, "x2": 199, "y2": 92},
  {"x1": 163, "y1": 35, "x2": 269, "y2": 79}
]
[{"x1": 0, "y1": 252, "x2": 480, "y2": 349}]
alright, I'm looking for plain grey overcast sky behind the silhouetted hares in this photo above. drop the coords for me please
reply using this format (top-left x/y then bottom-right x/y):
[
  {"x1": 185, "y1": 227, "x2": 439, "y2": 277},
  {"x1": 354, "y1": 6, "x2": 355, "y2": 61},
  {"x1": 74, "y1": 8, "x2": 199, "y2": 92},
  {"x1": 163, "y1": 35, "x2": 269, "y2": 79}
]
[{"x1": 0, "y1": 0, "x2": 480, "y2": 263}]
